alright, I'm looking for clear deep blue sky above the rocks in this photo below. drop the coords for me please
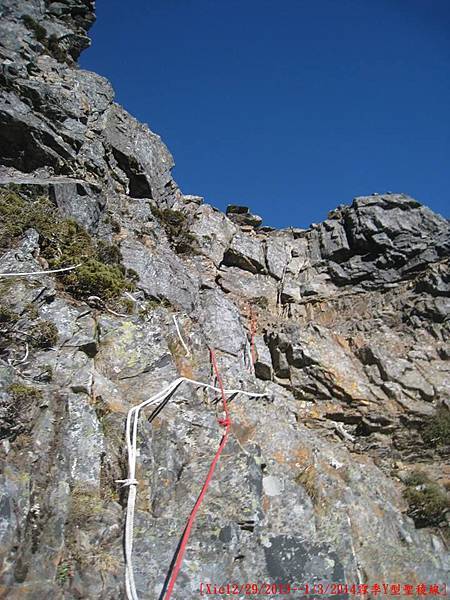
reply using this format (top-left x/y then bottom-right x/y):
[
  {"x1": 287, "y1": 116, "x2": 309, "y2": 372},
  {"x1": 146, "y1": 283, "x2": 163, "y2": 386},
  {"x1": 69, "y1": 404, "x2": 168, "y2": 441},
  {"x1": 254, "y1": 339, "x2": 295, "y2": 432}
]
[{"x1": 81, "y1": 0, "x2": 450, "y2": 227}]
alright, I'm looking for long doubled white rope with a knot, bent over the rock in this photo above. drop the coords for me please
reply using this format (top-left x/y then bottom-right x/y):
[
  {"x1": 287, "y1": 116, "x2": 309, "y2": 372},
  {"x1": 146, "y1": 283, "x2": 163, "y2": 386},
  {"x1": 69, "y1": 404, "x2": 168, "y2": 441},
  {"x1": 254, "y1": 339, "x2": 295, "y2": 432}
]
[{"x1": 121, "y1": 377, "x2": 266, "y2": 600}]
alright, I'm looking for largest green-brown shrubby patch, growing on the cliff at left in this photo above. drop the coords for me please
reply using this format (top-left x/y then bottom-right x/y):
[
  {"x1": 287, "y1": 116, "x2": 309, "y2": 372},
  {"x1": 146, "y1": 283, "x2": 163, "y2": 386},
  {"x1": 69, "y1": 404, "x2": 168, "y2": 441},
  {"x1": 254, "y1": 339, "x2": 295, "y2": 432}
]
[{"x1": 0, "y1": 188, "x2": 139, "y2": 300}]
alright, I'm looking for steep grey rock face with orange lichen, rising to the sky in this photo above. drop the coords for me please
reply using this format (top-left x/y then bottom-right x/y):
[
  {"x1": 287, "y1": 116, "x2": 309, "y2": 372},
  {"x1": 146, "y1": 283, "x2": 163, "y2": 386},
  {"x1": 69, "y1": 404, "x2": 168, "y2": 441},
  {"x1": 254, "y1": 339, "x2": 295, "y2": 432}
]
[{"x1": 0, "y1": 0, "x2": 450, "y2": 600}]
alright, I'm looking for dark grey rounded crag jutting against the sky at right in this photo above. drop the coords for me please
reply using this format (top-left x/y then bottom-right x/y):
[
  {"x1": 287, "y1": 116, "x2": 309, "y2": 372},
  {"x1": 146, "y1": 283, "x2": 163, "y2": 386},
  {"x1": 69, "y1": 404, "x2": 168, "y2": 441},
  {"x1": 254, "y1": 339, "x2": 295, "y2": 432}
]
[{"x1": 324, "y1": 194, "x2": 450, "y2": 288}]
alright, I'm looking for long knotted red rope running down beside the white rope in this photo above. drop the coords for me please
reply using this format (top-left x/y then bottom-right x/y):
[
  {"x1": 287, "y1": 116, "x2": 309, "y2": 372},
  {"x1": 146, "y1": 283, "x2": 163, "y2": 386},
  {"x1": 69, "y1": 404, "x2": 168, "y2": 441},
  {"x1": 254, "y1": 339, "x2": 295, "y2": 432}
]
[{"x1": 164, "y1": 349, "x2": 231, "y2": 600}]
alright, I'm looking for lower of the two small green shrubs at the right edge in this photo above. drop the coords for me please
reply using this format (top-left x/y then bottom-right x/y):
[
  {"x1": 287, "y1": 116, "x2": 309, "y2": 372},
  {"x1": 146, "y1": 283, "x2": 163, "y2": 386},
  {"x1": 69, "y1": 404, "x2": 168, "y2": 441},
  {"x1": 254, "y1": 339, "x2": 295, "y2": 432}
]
[{"x1": 403, "y1": 471, "x2": 450, "y2": 527}]
